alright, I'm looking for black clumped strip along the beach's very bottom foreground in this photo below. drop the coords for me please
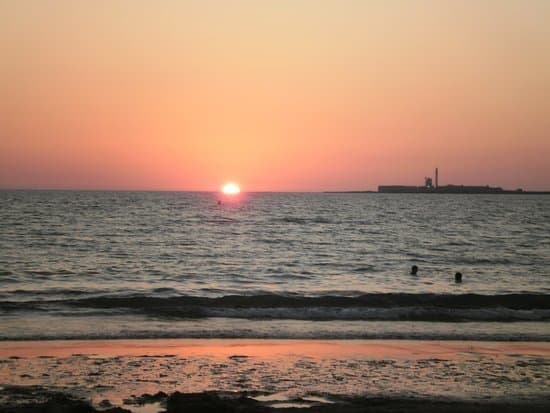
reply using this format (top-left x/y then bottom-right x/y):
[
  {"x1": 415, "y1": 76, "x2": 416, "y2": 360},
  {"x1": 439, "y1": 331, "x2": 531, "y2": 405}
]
[{"x1": 0, "y1": 386, "x2": 550, "y2": 413}]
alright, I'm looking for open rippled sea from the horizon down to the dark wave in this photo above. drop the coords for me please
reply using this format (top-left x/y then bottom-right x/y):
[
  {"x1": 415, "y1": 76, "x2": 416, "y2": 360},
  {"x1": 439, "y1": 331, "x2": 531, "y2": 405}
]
[{"x1": 0, "y1": 191, "x2": 550, "y2": 298}]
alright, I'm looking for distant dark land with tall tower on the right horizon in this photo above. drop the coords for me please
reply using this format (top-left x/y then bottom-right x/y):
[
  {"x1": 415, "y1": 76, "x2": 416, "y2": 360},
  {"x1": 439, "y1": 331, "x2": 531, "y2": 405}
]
[{"x1": 327, "y1": 168, "x2": 550, "y2": 195}]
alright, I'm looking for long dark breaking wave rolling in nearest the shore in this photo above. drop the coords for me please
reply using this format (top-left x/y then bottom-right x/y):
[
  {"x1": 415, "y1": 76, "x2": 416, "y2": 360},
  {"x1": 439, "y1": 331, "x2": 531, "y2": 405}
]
[{"x1": 0, "y1": 294, "x2": 550, "y2": 322}]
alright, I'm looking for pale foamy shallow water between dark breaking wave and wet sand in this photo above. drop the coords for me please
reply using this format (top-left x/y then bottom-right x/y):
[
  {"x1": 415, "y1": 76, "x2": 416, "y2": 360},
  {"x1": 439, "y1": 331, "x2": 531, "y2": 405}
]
[{"x1": 0, "y1": 313, "x2": 550, "y2": 342}]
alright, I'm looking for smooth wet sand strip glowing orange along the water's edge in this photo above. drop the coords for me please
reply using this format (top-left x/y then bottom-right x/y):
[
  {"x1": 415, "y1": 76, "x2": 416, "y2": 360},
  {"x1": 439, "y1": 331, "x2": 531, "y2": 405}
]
[{"x1": 0, "y1": 339, "x2": 550, "y2": 359}]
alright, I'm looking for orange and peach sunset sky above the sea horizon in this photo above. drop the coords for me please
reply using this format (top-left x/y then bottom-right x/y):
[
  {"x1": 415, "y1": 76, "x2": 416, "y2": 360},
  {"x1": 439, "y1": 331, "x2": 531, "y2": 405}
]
[{"x1": 0, "y1": 0, "x2": 550, "y2": 191}]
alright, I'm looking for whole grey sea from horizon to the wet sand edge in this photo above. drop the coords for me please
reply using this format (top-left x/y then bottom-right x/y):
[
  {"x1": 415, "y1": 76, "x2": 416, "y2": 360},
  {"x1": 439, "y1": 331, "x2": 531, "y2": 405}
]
[{"x1": 0, "y1": 191, "x2": 550, "y2": 341}]
